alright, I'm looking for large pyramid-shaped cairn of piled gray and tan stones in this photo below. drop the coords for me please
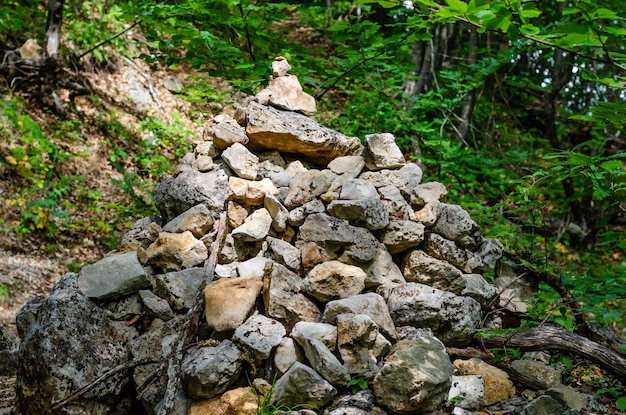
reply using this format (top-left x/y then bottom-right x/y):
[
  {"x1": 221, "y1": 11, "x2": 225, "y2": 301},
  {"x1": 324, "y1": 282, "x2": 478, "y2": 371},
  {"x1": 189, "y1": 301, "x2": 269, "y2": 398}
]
[{"x1": 17, "y1": 58, "x2": 511, "y2": 415}]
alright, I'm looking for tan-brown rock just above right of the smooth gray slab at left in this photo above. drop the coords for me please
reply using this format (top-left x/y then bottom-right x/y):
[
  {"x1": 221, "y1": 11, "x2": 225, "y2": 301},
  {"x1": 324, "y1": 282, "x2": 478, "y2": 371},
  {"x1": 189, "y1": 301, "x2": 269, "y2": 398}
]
[{"x1": 146, "y1": 231, "x2": 209, "y2": 272}]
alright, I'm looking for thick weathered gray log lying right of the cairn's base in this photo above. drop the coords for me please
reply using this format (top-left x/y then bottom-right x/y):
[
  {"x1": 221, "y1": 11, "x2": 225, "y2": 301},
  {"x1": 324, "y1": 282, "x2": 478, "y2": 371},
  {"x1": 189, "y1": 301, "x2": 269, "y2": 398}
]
[{"x1": 482, "y1": 325, "x2": 626, "y2": 378}]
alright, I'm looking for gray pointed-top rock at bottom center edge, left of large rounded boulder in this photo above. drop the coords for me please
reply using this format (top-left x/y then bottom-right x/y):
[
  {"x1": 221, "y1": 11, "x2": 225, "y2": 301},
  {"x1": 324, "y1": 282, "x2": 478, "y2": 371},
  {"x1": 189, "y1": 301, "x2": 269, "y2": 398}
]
[{"x1": 273, "y1": 362, "x2": 337, "y2": 408}]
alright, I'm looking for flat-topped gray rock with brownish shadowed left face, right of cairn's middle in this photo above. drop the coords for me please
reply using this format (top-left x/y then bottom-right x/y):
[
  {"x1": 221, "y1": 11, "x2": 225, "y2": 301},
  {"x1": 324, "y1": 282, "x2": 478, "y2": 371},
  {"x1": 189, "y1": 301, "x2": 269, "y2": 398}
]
[{"x1": 328, "y1": 199, "x2": 389, "y2": 230}]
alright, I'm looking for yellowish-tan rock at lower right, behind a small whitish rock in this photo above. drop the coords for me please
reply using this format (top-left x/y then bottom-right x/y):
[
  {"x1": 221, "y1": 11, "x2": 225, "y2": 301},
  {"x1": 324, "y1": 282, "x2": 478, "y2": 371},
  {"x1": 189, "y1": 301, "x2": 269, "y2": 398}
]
[{"x1": 453, "y1": 358, "x2": 515, "y2": 406}]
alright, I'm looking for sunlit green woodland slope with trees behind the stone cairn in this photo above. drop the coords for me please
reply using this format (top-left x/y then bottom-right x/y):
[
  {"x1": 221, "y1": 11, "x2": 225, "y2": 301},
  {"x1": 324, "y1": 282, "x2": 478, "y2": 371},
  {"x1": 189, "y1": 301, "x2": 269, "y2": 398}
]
[{"x1": 0, "y1": 0, "x2": 626, "y2": 396}]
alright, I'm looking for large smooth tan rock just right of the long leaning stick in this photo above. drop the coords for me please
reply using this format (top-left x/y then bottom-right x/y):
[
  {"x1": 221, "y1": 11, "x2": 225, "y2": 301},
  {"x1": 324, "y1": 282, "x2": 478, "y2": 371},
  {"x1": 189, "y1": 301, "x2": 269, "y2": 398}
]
[{"x1": 204, "y1": 277, "x2": 263, "y2": 331}]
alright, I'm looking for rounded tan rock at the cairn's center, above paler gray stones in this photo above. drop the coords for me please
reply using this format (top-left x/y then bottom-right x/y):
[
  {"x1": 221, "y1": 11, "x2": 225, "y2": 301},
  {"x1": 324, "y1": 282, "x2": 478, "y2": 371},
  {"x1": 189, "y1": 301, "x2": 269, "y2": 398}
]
[{"x1": 303, "y1": 261, "x2": 365, "y2": 303}]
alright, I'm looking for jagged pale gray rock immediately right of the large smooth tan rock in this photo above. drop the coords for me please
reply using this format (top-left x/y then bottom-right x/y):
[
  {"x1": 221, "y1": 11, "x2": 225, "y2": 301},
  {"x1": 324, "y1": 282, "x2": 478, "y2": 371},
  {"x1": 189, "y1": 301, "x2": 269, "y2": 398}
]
[{"x1": 263, "y1": 264, "x2": 322, "y2": 329}]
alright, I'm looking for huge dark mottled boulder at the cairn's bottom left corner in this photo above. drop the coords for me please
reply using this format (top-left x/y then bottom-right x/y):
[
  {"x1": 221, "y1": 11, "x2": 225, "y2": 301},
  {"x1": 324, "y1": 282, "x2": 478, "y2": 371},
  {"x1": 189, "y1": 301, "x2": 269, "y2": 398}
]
[{"x1": 16, "y1": 273, "x2": 130, "y2": 415}]
